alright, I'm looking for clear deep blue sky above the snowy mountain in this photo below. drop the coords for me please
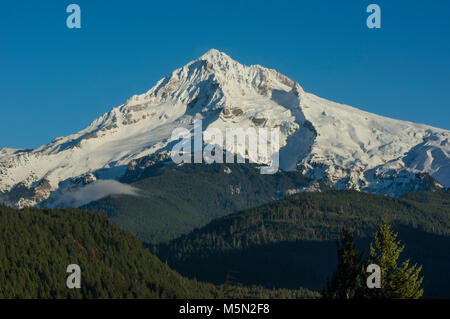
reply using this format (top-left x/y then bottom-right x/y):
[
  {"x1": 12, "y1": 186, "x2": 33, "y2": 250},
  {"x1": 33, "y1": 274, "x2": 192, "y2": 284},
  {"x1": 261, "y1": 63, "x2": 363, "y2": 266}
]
[{"x1": 0, "y1": 0, "x2": 450, "y2": 148}]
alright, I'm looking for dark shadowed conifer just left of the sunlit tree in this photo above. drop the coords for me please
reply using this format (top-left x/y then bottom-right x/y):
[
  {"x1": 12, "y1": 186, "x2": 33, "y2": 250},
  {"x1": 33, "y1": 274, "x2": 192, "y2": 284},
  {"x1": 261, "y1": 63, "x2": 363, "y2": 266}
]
[{"x1": 322, "y1": 228, "x2": 363, "y2": 299}]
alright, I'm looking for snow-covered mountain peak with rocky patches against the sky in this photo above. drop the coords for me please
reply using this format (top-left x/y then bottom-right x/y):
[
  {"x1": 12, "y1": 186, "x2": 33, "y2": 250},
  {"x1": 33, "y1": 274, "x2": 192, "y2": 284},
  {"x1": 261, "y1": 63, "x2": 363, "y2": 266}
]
[{"x1": 0, "y1": 49, "x2": 450, "y2": 207}]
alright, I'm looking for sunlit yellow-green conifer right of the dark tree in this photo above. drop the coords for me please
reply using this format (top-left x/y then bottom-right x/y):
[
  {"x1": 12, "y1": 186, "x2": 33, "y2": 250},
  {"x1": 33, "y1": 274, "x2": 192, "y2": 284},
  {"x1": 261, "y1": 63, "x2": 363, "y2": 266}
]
[{"x1": 366, "y1": 219, "x2": 423, "y2": 299}]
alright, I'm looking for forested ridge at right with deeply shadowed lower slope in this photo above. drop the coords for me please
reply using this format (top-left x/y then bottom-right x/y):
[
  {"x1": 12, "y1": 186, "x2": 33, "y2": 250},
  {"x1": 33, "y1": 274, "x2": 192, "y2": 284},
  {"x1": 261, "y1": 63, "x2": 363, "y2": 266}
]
[{"x1": 154, "y1": 191, "x2": 450, "y2": 298}]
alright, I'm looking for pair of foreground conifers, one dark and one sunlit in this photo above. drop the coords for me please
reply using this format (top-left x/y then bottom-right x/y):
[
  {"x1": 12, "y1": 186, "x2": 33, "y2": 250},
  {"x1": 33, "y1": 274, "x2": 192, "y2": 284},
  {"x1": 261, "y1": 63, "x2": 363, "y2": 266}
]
[{"x1": 322, "y1": 222, "x2": 424, "y2": 299}]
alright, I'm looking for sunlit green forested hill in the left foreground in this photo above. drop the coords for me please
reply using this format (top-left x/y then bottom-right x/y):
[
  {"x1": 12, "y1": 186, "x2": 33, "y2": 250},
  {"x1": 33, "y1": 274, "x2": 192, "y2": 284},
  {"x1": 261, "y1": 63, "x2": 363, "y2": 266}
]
[{"x1": 0, "y1": 205, "x2": 319, "y2": 298}]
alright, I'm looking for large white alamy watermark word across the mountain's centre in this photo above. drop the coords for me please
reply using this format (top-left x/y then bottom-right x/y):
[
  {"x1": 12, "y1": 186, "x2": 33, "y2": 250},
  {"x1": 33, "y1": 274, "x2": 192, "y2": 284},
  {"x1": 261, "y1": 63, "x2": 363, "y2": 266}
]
[{"x1": 170, "y1": 120, "x2": 280, "y2": 174}]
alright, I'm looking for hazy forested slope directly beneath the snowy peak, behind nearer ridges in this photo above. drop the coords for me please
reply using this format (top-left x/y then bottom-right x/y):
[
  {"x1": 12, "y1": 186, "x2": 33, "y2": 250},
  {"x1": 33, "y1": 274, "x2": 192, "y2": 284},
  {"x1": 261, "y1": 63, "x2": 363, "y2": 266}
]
[{"x1": 80, "y1": 164, "x2": 307, "y2": 243}]
